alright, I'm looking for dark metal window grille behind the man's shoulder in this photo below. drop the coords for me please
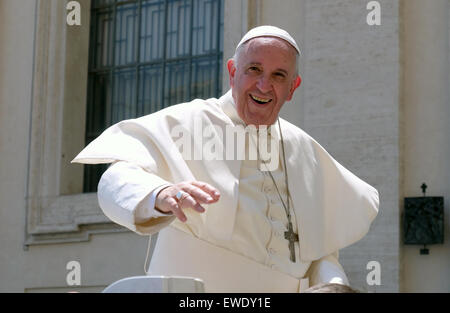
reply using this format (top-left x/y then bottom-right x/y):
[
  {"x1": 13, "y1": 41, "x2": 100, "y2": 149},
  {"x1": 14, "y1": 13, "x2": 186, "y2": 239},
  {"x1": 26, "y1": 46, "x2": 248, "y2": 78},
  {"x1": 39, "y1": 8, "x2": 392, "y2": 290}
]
[{"x1": 83, "y1": 0, "x2": 223, "y2": 192}]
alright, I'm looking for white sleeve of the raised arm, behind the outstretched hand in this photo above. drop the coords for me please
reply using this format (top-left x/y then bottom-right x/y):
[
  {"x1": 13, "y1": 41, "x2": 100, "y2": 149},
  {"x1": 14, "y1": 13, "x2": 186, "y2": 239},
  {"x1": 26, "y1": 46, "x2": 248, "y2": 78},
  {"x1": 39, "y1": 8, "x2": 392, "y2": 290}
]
[{"x1": 97, "y1": 161, "x2": 174, "y2": 234}]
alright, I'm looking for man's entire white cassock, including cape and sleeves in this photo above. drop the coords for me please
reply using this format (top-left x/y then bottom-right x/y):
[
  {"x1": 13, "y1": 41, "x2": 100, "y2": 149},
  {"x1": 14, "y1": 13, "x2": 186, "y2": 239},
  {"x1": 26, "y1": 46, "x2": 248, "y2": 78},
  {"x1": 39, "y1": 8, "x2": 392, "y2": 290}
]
[{"x1": 73, "y1": 91, "x2": 379, "y2": 292}]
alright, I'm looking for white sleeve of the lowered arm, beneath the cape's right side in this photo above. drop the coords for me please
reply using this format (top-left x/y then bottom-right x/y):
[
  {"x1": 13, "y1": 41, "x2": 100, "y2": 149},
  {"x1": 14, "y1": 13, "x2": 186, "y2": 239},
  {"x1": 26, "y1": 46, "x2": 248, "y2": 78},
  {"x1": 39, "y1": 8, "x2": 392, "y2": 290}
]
[{"x1": 308, "y1": 251, "x2": 350, "y2": 287}]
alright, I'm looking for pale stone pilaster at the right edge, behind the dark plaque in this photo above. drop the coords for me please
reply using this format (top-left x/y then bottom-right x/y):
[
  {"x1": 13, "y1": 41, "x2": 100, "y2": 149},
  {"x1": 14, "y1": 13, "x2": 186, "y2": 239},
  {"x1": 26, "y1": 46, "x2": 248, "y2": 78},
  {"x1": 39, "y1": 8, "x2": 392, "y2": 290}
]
[{"x1": 400, "y1": 0, "x2": 450, "y2": 292}]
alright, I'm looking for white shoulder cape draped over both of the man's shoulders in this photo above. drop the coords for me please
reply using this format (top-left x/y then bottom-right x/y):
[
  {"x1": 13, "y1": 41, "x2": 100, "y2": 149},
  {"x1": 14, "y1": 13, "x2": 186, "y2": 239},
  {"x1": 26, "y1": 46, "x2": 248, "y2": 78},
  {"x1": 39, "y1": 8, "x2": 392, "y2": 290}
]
[{"x1": 72, "y1": 91, "x2": 379, "y2": 262}]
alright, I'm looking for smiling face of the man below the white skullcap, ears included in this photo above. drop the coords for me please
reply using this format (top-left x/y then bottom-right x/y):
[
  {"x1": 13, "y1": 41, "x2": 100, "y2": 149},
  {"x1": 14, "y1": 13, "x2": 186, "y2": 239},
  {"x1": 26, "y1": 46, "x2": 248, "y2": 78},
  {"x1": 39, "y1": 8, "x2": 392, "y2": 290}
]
[{"x1": 228, "y1": 37, "x2": 301, "y2": 126}]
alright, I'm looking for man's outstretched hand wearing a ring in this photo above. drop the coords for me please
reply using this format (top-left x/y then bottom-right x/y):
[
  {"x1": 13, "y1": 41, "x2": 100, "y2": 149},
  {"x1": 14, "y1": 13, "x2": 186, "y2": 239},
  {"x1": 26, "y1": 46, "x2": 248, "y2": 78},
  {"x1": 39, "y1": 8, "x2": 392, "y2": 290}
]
[{"x1": 155, "y1": 181, "x2": 220, "y2": 223}]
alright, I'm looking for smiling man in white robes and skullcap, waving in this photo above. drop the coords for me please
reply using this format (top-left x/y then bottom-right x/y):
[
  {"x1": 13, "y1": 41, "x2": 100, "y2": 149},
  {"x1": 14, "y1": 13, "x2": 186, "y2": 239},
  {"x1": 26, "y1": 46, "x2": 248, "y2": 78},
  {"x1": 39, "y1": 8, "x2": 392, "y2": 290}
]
[{"x1": 73, "y1": 26, "x2": 379, "y2": 292}]
